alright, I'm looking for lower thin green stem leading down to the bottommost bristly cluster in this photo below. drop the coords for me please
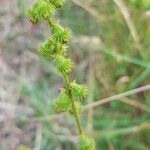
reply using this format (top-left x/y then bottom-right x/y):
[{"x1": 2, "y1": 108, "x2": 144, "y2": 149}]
[{"x1": 63, "y1": 74, "x2": 82, "y2": 135}]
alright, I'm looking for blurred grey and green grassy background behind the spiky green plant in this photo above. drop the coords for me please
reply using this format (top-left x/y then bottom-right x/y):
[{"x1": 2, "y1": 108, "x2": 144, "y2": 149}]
[{"x1": 0, "y1": 0, "x2": 150, "y2": 150}]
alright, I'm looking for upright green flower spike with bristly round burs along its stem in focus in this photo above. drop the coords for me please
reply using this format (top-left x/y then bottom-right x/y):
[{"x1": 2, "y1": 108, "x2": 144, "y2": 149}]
[{"x1": 27, "y1": 0, "x2": 94, "y2": 150}]
